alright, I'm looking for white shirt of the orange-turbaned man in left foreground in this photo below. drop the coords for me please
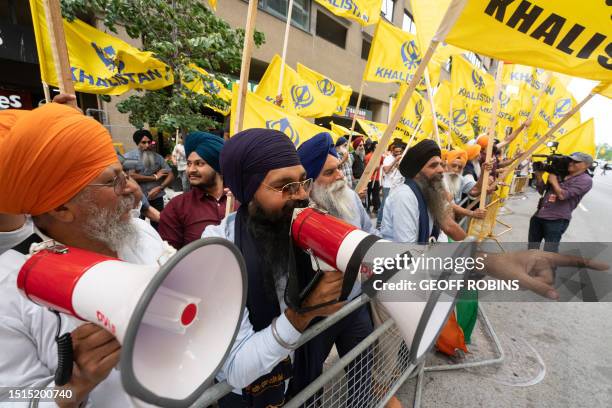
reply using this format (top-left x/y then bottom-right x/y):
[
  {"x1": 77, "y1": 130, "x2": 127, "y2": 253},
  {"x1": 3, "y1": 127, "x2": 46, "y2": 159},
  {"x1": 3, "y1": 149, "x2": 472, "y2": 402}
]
[{"x1": 0, "y1": 219, "x2": 165, "y2": 408}]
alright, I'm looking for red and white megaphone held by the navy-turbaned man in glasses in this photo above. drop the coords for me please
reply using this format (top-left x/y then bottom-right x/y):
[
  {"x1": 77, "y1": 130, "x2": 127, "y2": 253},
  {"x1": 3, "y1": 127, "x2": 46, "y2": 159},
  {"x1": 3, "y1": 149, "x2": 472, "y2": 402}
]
[{"x1": 291, "y1": 208, "x2": 473, "y2": 364}]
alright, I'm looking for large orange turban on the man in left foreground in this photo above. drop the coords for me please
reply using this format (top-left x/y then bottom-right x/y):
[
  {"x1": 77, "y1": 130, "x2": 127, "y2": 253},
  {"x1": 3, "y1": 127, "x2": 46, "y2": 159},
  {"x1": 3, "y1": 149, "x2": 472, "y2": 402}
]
[{"x1": 0, "y1": 103, "x2": 118, "y2": 215}]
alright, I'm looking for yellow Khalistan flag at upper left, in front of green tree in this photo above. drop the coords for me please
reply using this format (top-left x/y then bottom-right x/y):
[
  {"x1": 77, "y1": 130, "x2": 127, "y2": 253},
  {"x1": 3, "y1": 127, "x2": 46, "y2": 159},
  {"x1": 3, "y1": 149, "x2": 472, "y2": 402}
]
[{"x1": 30, "y1": 0, "x2": 174, "y2": 95}]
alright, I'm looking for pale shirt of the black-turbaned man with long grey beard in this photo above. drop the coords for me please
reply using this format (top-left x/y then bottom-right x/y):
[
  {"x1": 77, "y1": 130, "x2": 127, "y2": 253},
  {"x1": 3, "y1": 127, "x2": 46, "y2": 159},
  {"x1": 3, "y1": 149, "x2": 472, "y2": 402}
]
[{"x1": 380, "y1": 184, "x2": 433, "y2": 243}]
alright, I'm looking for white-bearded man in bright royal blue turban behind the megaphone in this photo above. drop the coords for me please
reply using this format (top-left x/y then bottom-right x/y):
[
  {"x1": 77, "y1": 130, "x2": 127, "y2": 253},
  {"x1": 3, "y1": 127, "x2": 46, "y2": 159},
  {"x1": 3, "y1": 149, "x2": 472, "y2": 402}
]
[{"x1": 297, "y1": 133, "x2": 374, "y2": 233}]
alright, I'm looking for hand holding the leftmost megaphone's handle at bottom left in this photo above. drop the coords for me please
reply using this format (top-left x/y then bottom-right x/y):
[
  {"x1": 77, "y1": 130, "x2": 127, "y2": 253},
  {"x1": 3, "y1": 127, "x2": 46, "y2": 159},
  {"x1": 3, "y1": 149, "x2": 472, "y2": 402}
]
[{"x1": 56, "y1": 323, "x2": 121, "y2": 408}]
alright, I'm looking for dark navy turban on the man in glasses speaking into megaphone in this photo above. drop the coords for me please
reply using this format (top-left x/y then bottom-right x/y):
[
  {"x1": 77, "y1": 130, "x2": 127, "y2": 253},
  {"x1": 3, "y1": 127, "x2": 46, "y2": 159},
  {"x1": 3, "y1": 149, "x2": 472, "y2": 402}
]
[{"x1": 221, "y1": 129, "x2": 300, "y2": 205}]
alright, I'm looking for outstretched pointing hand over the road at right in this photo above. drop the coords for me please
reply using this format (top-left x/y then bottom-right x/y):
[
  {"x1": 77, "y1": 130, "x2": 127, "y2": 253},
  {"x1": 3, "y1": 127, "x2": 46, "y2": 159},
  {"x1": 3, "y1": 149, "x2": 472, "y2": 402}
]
[{"x1": 484, "y1": 250, "x2": 610, "y2": 300}]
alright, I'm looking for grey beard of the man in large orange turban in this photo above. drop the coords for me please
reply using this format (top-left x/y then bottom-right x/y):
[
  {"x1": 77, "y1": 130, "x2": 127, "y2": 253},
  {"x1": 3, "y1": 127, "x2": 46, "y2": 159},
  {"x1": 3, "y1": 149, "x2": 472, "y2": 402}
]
[{"x1": 83, "y1": 191, "x2": 137, "y2": 252}]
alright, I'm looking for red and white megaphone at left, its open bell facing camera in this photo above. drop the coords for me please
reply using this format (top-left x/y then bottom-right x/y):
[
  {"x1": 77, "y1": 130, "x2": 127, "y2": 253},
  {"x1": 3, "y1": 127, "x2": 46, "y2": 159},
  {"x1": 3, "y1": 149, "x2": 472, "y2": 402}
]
[{"x1": 17, "y1": 238, "x2": 247, "y2": 407}]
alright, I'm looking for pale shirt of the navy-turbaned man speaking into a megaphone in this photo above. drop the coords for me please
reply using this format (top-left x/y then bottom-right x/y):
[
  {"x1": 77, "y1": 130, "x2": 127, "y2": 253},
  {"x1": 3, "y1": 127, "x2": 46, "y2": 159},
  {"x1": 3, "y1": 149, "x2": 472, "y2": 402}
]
[{"x1": 202, "y1": 213, "x2": 301, "y2": 388}]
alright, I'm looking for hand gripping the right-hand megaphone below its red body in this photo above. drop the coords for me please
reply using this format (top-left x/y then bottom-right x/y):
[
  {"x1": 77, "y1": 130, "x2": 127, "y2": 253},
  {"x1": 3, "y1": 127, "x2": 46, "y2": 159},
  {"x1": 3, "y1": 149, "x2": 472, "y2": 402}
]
[{"x1": 285, "y1": 271, "x2": 345, "y2": 332}]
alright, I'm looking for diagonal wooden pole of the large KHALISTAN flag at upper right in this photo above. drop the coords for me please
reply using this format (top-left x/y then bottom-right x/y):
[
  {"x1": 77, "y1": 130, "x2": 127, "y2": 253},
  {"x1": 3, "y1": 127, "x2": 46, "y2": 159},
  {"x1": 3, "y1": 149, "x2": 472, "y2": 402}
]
[{"x1": 355, "y1": 40, "x2": 440, "y2": 193}]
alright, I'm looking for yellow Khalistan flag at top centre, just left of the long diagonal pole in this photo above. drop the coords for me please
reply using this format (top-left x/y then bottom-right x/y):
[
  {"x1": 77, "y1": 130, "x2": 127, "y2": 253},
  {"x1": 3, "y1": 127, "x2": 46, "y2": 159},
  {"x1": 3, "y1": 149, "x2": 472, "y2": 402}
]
[{"x1": 363, "y1": 19, "x2": 421, "y2": 82}]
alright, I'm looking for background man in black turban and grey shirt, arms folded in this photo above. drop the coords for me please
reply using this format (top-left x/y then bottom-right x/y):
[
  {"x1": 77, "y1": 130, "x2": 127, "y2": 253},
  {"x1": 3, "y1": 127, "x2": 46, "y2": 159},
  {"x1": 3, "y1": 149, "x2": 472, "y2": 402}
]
[{"x1": 123, "y1": 129, "x2": 174, "y2": 229}]
